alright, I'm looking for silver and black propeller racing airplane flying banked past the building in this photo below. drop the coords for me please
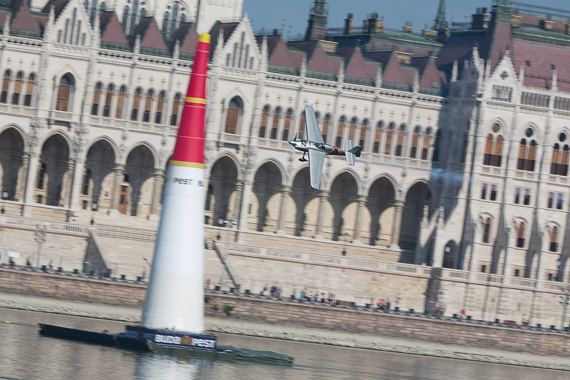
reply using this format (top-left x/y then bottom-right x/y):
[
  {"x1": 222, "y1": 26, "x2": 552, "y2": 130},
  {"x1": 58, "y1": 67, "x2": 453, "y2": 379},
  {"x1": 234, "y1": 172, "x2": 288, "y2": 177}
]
[{"x1": 289, "y1": 105, "x2": 362, "y2": 190}]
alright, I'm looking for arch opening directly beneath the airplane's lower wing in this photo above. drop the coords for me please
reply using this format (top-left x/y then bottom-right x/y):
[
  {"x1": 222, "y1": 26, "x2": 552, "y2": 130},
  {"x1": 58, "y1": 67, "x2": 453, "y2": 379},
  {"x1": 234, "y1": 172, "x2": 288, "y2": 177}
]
[{"x1": 286, "y1": 166, "x2": 320, "y2": 237}]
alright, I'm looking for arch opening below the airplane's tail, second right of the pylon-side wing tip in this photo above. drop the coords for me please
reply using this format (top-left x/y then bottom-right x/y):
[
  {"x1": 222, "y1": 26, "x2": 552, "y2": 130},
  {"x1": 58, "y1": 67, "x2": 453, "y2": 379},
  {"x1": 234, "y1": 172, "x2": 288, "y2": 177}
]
[{"x1": 321, "y1": 170, "x2": 359, "y2": 241}]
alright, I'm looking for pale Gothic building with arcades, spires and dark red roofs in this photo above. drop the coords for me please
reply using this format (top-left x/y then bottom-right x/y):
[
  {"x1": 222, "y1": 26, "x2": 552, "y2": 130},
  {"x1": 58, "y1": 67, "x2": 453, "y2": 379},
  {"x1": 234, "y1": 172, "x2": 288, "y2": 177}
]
[{"x1": 0, "y1": 0, "x2": 570, "y2": 281}]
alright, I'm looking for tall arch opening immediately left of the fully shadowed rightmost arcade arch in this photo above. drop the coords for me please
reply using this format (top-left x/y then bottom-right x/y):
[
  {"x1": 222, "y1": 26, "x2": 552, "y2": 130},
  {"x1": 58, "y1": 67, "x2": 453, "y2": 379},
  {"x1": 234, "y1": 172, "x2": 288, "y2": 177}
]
[{"x1": 363, "y1": 175, "x2": 397, "y2": 246}]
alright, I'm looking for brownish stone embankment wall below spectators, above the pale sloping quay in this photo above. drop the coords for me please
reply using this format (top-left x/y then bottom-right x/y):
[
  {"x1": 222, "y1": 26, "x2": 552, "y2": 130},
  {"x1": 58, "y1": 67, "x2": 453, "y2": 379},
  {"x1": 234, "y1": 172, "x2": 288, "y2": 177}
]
[{"x1": 0, "y1": 268, "x2": 570, "y2": 356}]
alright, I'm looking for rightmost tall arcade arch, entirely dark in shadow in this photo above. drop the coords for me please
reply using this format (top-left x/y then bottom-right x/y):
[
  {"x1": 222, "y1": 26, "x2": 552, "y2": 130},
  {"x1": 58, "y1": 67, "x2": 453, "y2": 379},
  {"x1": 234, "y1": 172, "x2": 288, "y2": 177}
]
[{"x1": 398, "y1": 180, "x2": 434, "y2": 255}]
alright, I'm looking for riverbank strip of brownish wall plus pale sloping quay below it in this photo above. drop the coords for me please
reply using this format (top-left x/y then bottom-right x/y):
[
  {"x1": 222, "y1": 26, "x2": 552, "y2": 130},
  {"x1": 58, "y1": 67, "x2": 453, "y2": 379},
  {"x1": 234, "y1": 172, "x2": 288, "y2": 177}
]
[{"x1": 0, "y1": 268, "x2": 570, "y2": 370}]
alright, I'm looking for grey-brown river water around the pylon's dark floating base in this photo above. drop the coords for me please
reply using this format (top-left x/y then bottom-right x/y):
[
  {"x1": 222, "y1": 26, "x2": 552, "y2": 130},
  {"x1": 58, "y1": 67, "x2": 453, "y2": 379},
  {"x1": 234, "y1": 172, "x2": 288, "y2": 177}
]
[{"x1": 0, "y1": 309, "x2": 570, "y2": 380}]
